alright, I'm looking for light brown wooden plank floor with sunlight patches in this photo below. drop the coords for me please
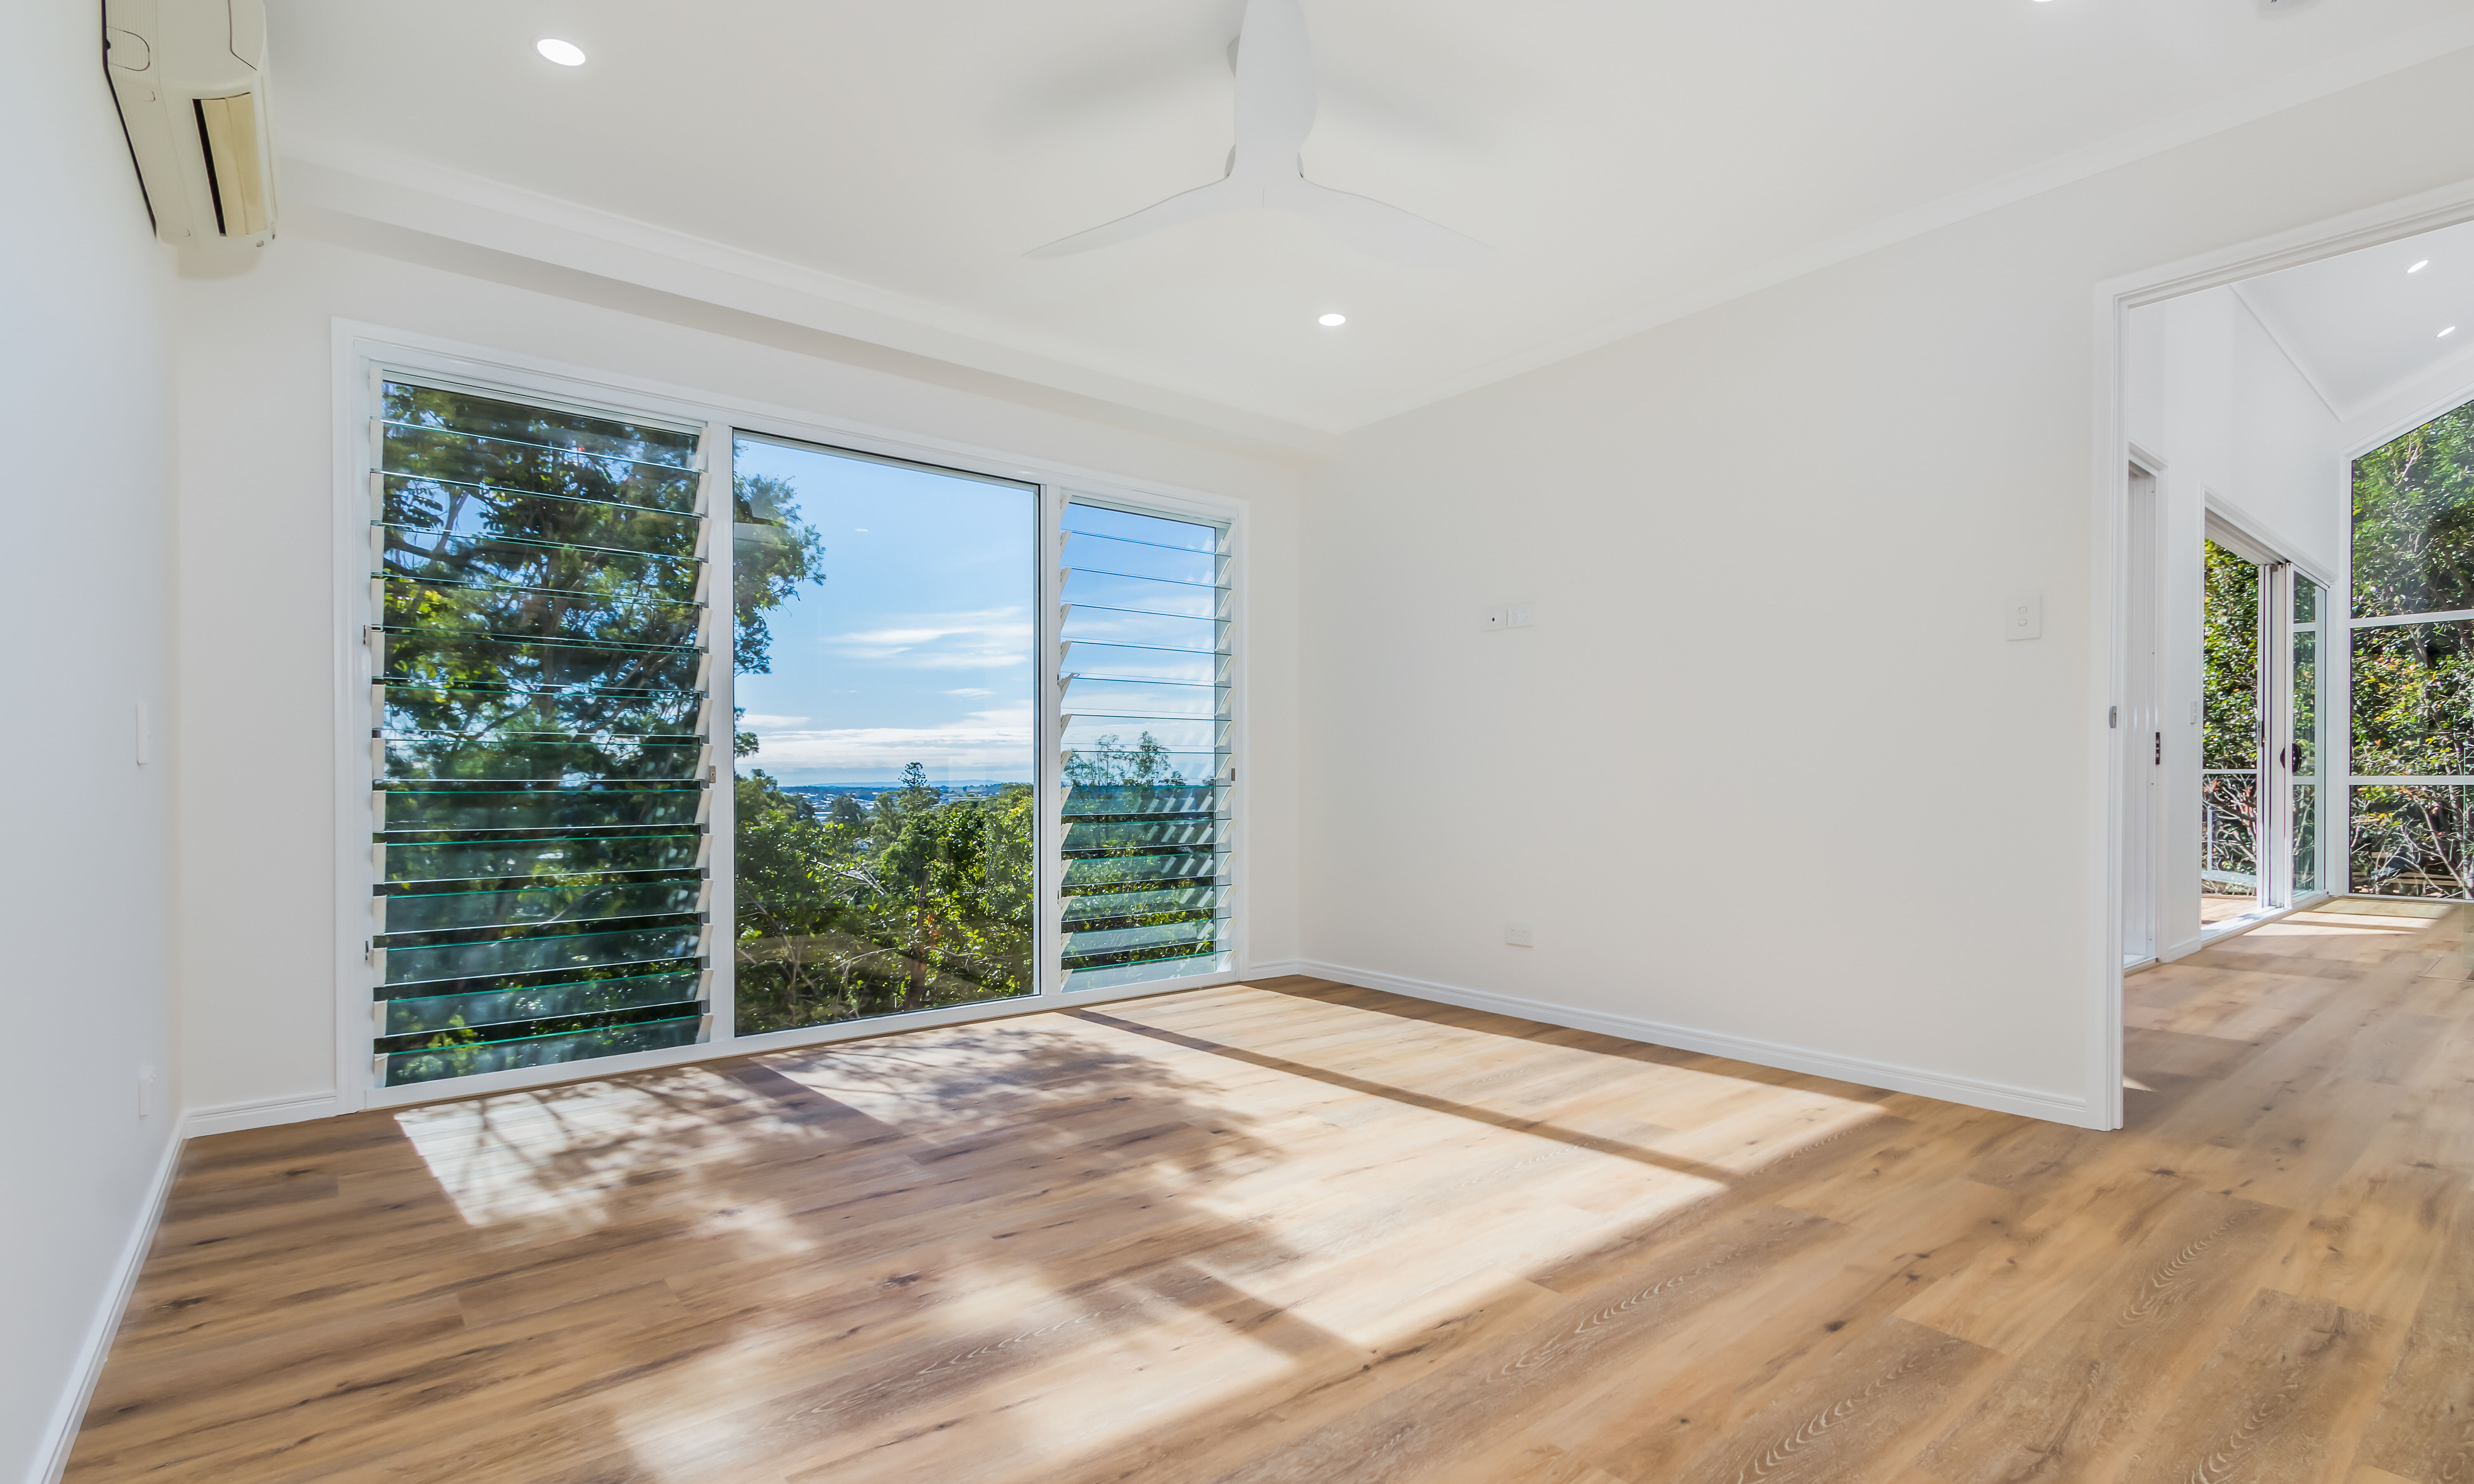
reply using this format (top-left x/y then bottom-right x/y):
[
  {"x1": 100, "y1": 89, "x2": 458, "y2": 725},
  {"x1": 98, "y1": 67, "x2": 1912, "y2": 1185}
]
[{"x1": 69, "y1": 913, "x2": 2474, "y2": 1484}]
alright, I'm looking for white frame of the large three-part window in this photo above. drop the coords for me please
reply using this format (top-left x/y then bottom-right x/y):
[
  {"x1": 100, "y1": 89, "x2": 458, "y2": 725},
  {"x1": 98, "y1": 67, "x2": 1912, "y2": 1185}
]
[{"x1": 332, "y1": 319, "x2": 1252, "y2": 1113}]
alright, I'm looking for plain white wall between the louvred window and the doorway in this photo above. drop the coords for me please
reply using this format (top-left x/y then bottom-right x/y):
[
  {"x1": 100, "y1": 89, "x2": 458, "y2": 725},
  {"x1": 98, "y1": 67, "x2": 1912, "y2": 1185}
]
[{"x1": 1301, "y1": 40, "x2": 2474, "y2": 1115}]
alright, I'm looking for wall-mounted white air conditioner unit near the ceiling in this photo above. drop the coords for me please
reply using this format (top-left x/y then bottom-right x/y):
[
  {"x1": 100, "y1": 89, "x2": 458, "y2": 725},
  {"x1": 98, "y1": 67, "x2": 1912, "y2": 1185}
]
[{"x1": 104, "y1": 0, "x2": 275, "y2": 247}]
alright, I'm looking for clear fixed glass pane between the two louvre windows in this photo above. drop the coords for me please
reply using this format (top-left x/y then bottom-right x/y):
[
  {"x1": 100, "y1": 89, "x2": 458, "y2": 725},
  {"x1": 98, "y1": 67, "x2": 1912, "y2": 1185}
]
[{"x1": 735, "y1": 438, "x2": 1039, "y2": 1034}]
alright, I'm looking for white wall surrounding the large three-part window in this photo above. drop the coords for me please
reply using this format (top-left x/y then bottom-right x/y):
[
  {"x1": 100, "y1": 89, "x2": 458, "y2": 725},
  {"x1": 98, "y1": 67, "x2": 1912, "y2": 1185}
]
[{"x1": 181, "y1": 230, "x2": 1296, "y2": 1120}]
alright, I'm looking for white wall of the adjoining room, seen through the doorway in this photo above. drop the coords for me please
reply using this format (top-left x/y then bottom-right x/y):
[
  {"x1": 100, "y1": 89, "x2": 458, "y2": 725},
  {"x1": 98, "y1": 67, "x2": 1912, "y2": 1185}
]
[{"x1": 2123, "y1": 287, "x2": 2350, "y2": 960}]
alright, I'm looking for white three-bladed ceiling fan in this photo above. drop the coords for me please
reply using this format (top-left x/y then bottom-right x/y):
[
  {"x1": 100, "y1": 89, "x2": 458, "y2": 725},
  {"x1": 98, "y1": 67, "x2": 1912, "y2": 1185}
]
[{"x1": 1024, "y1": 0, "x2": 1494, "y2": 267}]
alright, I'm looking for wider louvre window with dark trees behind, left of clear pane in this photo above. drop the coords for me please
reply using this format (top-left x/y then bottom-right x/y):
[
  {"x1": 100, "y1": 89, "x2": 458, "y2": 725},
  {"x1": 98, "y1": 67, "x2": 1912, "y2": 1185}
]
[{"x1": 369, "y1": 379, "x2": 713, "y2": 1086}]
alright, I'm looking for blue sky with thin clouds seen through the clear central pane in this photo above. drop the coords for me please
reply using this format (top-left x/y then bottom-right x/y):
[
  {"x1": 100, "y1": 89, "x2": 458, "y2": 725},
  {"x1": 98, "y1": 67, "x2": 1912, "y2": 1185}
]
[{"x1": 737, "y1": 440, "x2": 1039, "y2": 784}]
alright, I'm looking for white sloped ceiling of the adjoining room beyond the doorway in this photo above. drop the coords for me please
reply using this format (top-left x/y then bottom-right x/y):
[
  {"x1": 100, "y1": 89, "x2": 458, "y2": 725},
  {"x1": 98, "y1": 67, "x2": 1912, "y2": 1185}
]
[{"x1": 2236, "y1": 223, "x2": 2474, "y2": 418}]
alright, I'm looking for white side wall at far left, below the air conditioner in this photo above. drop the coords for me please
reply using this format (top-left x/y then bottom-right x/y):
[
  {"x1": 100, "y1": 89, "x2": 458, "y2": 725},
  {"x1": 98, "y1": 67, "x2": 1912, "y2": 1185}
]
[{"x1": 0, "y1": 0, "x2": 178, "y2": 1479}]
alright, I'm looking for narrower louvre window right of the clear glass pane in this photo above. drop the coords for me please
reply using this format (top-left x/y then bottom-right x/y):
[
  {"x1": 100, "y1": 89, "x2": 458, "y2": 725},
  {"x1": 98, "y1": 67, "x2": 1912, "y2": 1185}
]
[{"x1": 1059, "y1": 500, "x2": 1235, "y2": 989}]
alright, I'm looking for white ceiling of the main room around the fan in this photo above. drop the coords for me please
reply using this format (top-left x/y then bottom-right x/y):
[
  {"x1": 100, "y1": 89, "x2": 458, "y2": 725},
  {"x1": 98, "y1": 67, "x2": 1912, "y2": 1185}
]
[{"x1": 270, "y1": 0, "x2": 2474, "y2": 430}]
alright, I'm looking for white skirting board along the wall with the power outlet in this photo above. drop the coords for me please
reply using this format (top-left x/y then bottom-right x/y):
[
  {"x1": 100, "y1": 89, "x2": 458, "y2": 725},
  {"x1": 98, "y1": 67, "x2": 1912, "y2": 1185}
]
[{"x1": 1299, "y1": 960, "x2": 2095, "y2": 1128}]
